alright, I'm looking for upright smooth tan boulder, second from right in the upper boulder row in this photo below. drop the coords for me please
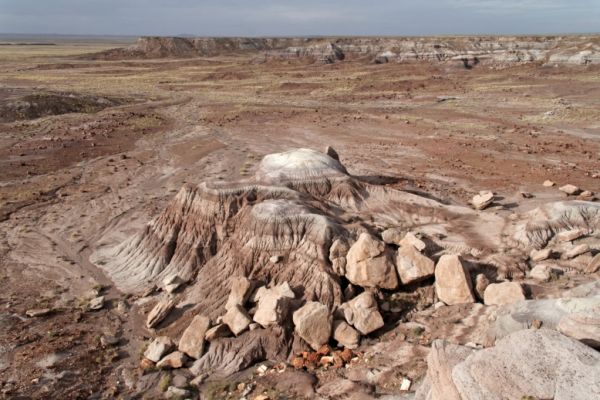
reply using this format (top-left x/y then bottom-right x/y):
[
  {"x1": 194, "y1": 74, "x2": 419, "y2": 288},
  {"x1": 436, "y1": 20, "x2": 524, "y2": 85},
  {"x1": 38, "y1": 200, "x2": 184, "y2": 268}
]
[{"x1": 435, "y1": 255, "x2": 475, "y2": 305}]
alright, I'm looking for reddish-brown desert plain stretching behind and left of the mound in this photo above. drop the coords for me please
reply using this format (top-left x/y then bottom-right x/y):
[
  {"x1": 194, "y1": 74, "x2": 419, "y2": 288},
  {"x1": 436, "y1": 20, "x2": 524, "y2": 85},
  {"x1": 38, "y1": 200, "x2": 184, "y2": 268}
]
[{"x1": 0, "y1": 43, "x2": 600, "y2": 399}]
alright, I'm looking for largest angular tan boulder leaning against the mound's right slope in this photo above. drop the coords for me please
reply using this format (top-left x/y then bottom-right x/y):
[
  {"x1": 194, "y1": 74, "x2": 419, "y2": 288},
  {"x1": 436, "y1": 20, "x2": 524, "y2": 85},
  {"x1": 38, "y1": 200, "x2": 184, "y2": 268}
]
[{"x1": 346, "y1": 232, "x2": 398, "y2": 289}]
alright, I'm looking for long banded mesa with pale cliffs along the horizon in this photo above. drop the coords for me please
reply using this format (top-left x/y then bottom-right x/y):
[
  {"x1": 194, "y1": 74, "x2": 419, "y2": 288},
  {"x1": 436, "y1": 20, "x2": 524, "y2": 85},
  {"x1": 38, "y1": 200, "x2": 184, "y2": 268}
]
[{"x1": 85, "y1": 35, "x2": 600, "y2": 69}]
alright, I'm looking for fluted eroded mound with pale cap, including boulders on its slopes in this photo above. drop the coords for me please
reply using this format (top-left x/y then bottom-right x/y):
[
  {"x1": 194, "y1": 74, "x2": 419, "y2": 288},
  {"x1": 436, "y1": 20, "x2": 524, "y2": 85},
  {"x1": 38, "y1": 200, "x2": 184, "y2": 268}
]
[{"x1": 92, "y1": 148, "x2": 600, "y2": 384}]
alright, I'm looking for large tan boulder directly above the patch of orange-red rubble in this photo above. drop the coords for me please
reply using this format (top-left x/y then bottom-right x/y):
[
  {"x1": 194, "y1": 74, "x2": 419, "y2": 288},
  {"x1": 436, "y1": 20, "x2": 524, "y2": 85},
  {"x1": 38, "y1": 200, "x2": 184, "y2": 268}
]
[{"x1": 293, "y1": 301, "x2": 332, "y2": 350}]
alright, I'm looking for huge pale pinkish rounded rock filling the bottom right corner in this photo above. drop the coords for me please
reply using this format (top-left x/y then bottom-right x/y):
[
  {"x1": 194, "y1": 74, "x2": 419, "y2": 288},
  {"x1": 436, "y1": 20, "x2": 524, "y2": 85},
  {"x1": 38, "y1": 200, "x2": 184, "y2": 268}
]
[{"x1": 452, "y1": 329, "x2": 600, "y2": 400}]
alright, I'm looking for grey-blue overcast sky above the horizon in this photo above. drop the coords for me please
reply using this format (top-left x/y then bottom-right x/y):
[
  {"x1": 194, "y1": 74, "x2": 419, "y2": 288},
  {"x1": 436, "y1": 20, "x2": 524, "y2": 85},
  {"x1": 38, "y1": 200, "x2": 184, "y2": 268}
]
[{"x1": 0, "y1": 0, "x2": 600, "y2": 36}]
